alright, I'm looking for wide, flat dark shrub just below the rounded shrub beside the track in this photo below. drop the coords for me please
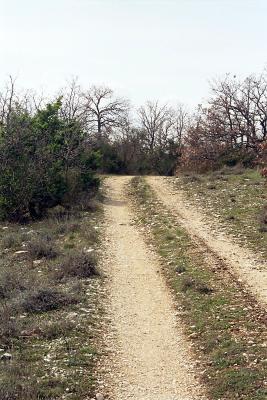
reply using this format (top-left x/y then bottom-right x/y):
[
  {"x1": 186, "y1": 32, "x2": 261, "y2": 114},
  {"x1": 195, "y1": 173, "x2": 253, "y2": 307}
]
[{"x1": 21, "y1": 287, "x2": 77, "y2": 313}]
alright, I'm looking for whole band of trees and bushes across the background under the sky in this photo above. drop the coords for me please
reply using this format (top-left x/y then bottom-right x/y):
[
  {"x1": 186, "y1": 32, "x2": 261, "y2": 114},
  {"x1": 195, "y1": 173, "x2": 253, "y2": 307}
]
[{"x1": 0, "y1": 72, "x2": 267, "y2": 220}]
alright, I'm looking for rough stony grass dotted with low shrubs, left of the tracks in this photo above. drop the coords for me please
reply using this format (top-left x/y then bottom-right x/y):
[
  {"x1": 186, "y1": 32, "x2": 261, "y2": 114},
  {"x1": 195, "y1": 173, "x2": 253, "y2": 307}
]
[{"x1": 0, "y1": 192, "x2": 105, "y2": 400}]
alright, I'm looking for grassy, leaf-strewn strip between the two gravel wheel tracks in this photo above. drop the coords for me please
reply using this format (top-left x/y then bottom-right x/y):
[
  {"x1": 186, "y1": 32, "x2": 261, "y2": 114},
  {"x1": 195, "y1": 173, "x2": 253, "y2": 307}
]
[{"x1": 129, "y1": 178, "x2": 267, "y2": 400}]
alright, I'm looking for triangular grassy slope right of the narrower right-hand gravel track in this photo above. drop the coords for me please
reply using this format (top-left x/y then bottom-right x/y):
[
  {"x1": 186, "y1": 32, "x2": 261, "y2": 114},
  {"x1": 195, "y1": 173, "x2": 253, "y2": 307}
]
[{"x1": 170, "y1": 168, "x2": 267, "y2": 258}]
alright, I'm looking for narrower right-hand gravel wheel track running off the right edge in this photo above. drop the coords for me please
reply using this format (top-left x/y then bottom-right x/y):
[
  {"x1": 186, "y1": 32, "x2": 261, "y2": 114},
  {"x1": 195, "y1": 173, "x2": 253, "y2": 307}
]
[{"x1": 146, "y1": 176, "x2": 267, "y2": 306}]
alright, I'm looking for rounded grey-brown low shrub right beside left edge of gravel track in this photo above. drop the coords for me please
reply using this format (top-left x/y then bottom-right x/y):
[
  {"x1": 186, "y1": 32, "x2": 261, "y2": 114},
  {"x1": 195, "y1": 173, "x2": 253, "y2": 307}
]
[{"x1": 56, "y1": 251, "x2": 98, "y2": 279}]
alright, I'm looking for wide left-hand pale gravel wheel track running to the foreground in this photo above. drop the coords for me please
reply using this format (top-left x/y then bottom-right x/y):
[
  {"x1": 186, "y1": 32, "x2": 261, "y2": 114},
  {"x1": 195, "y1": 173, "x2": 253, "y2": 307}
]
[{"x1": 102, "y1": 177, "x2": 206, "y2": 400}]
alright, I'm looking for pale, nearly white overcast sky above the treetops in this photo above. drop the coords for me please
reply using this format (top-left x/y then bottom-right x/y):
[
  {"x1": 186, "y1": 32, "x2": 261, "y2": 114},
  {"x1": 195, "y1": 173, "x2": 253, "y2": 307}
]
[{"x1": 0, "y1": 0, "x2": 267, "y2": 106}]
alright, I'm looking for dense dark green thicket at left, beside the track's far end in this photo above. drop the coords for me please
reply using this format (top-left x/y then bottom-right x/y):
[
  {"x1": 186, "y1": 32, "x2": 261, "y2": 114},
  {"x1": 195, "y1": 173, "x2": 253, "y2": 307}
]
[{"x1": 0, "y1": 82, "x2": 99, "y2": 221}]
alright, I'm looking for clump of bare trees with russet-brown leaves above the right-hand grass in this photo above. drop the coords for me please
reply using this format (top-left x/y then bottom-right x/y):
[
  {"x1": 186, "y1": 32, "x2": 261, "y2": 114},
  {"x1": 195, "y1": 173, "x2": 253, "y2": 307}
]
[{"x1": 183, "y1": 72, "x2": 267, "y2": 175}]
